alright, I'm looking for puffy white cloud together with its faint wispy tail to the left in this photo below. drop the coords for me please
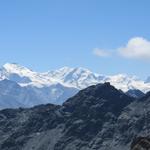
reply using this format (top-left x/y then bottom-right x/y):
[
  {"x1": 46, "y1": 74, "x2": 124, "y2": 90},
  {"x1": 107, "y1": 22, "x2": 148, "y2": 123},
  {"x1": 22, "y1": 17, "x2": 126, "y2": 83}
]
[{"x1": 93, "y1": 37, "x2": 150, "y2": 60}]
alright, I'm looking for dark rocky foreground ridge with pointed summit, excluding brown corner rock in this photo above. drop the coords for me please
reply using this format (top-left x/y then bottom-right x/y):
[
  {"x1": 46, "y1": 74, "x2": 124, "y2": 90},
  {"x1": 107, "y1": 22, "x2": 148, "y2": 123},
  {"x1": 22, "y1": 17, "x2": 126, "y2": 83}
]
[{"x1": 0, "y1": 83, "x2": 150, "y2": 150}]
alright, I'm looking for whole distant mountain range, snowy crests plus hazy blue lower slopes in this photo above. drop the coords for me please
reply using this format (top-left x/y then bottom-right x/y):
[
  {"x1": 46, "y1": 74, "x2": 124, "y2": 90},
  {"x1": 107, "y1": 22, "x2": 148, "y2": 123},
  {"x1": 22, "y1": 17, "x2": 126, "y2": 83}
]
[{"x1": 0, "y1": 63, "x2": 150, "y2": 108}]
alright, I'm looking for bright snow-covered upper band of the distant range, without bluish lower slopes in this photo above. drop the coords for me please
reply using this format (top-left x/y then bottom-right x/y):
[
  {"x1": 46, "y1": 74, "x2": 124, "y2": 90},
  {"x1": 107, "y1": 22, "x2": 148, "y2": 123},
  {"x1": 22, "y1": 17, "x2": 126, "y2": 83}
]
[{"x1": 0, "y1": 63, "x2": 150, "y2": 92}]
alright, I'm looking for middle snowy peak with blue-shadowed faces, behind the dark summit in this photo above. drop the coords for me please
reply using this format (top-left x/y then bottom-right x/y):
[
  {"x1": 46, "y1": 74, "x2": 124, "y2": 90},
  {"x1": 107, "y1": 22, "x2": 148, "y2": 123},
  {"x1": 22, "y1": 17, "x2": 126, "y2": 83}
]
[{"x1": 48, "y1": 67, "x2": 102, "y2": 89}]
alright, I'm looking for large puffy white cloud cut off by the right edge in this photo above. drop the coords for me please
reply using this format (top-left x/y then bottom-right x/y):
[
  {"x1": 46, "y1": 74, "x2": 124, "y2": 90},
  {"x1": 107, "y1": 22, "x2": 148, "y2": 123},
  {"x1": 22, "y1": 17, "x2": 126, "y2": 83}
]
[{"x1": 118, "y1": 37, "x2": 150, "y2": 59}]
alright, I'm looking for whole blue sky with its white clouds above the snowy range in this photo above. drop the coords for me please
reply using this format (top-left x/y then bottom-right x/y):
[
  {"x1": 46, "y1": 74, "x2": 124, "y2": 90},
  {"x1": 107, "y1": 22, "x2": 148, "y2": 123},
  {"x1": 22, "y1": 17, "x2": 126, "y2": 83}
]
[{"x1": 0, "y1": 0, "x2": 150, "y2": 78}]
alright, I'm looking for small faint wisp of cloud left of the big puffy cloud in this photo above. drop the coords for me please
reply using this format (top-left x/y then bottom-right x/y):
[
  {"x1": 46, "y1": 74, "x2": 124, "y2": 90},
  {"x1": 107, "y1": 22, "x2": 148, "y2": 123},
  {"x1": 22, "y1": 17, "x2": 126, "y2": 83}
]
[{"x1": 93, "y1": 48, "x2": 110, "y2": 57}]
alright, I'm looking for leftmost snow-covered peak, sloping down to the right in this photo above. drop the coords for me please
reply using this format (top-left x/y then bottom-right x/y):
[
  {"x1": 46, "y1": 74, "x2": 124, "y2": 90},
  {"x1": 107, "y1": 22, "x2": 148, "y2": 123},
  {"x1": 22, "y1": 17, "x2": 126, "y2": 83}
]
[{"x1": 0, "y1": 63, "x2": 58, "y2": 87}]
